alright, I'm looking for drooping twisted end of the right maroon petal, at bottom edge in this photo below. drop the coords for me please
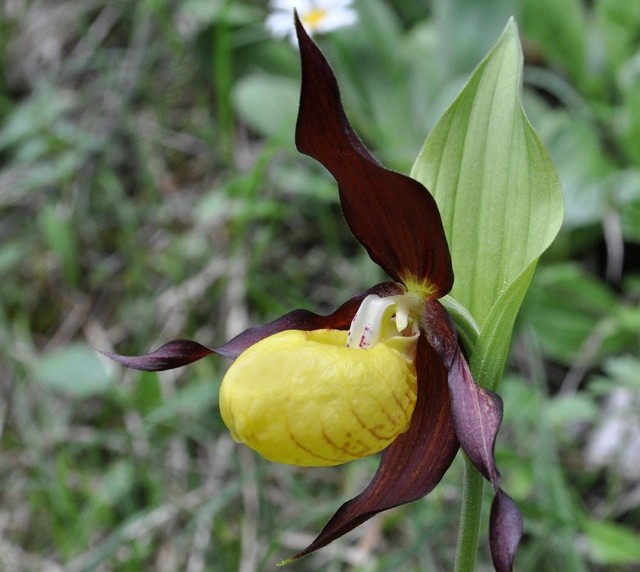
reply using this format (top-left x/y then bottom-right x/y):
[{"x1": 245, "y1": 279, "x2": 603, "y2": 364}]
[{"x1": 489, "y1": 490, "x2": 522, "y2": 572}]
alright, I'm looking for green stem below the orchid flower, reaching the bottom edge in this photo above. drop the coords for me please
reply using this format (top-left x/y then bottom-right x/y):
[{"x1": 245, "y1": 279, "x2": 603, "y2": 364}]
[{"x1": 454, "y1": 457, "x2": 484, "y2": 572}]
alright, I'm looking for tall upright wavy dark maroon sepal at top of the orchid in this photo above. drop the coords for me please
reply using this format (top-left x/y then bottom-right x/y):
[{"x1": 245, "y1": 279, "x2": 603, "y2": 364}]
[{"x1": 296, "y1": 17, "x2": 453, "y2": 296}]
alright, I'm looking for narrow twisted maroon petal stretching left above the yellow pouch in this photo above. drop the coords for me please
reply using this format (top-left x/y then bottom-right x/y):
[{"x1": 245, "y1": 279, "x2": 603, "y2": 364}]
[{"x1": 101, "y1": 282, "x2": 405, "y2": 371}]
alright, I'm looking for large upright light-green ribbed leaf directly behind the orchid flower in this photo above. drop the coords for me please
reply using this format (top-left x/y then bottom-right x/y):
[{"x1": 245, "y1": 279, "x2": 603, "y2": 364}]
[{"x1": 412, "y1": 20, "x2": 563, "y2": 336}]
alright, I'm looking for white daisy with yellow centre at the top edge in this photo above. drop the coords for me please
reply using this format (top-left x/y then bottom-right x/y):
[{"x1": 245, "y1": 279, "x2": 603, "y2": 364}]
[{"x1": 266, "y1": 0, "x2": 358, "y2": 44}]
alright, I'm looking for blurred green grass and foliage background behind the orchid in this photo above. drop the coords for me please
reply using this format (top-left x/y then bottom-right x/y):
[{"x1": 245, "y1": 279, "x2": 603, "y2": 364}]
[{"x1": 0, "y1": 0, "x2": 640, "y2": 572}]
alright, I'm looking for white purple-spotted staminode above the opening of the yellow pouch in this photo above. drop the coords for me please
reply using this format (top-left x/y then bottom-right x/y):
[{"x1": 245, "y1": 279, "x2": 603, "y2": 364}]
[{"x1": 347, "y1": 294, "x2": 418, "y2": 351}]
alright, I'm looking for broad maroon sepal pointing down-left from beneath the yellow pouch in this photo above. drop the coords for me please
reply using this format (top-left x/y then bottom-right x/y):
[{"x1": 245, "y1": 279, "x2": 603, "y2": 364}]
[{"x1": 291, "y1": 336, "x2": 458, "y2": 560}]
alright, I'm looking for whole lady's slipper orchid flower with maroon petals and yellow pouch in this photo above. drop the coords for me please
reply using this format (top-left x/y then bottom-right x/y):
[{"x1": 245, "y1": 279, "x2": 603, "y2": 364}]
[{"x1": 108, "y1": 18, "x2": 522, "y2": 571}]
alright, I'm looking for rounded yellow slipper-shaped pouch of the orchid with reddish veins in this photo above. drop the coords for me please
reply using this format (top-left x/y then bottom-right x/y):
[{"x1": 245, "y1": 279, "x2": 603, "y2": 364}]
[{"x1": 220, "y1": 292, "x2": 417, "y2": 466}]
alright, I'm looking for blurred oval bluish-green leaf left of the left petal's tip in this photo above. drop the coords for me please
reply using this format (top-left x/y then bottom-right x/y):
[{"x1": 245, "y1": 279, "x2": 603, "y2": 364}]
[{"x1": 34, "y1": 343, "x2": 112, "y2": 398}]
